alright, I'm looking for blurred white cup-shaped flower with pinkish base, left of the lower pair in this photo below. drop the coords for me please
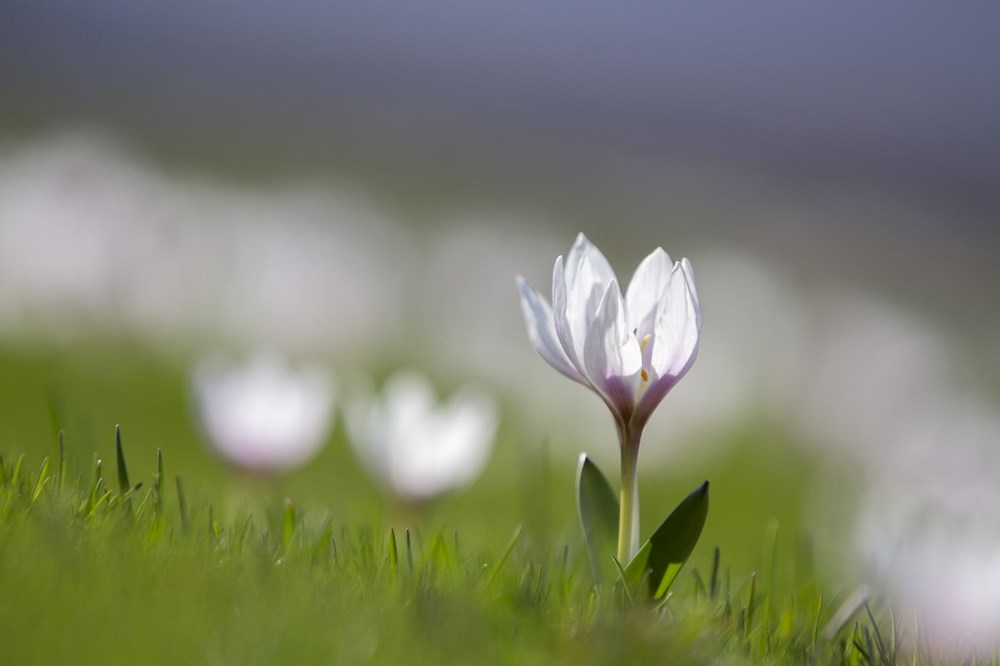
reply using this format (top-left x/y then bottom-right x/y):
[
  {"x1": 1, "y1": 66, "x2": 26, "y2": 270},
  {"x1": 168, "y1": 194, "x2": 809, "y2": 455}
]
[{"x1": 194, "y1": 356, "x2": 334, "y2": 472}]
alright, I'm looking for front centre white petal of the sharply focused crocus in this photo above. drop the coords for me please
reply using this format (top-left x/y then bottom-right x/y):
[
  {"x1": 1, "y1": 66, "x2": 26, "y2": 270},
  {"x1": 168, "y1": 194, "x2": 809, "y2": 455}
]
[{"x1": 584, "y1": 280, "x2": 642, "y2": 416}]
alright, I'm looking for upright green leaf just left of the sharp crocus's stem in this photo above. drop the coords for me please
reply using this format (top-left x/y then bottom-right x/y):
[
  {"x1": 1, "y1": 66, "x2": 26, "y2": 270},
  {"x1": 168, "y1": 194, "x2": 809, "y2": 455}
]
[{"x1": 576, "y1": 453, "x2": 618, "y2": 583}]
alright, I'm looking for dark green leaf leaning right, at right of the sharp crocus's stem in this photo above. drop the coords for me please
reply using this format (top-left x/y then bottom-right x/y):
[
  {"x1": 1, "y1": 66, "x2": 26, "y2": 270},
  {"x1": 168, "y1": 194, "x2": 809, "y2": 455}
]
[{"x1": 625, "y1": 481, "x2": 708, "y2": 600}]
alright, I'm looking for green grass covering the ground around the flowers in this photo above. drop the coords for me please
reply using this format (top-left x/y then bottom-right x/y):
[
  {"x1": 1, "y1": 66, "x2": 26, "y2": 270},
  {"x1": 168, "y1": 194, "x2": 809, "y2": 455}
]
[{"x1": 0, "y1": 349, "x2": 976, "y2": 665}]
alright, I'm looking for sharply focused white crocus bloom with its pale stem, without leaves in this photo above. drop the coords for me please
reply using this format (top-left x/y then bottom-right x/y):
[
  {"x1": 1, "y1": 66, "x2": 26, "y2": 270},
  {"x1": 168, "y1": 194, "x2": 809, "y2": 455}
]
[{"x1": 517, "y1": 234, "x2": 701, "y2": 563}]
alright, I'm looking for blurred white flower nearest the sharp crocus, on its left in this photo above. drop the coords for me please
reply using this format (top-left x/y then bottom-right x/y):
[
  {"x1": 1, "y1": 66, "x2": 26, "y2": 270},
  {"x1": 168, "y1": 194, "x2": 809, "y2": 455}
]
[{"x1": 346, "y1": 372, "x2": 497, "y2": 501}]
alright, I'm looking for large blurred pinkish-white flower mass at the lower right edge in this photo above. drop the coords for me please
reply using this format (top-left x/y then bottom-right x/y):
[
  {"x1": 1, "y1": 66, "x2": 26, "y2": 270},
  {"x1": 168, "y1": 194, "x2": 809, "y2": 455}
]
[{"x1": 853, "y1": 396, "x2": 1000, "y2": 649}]
